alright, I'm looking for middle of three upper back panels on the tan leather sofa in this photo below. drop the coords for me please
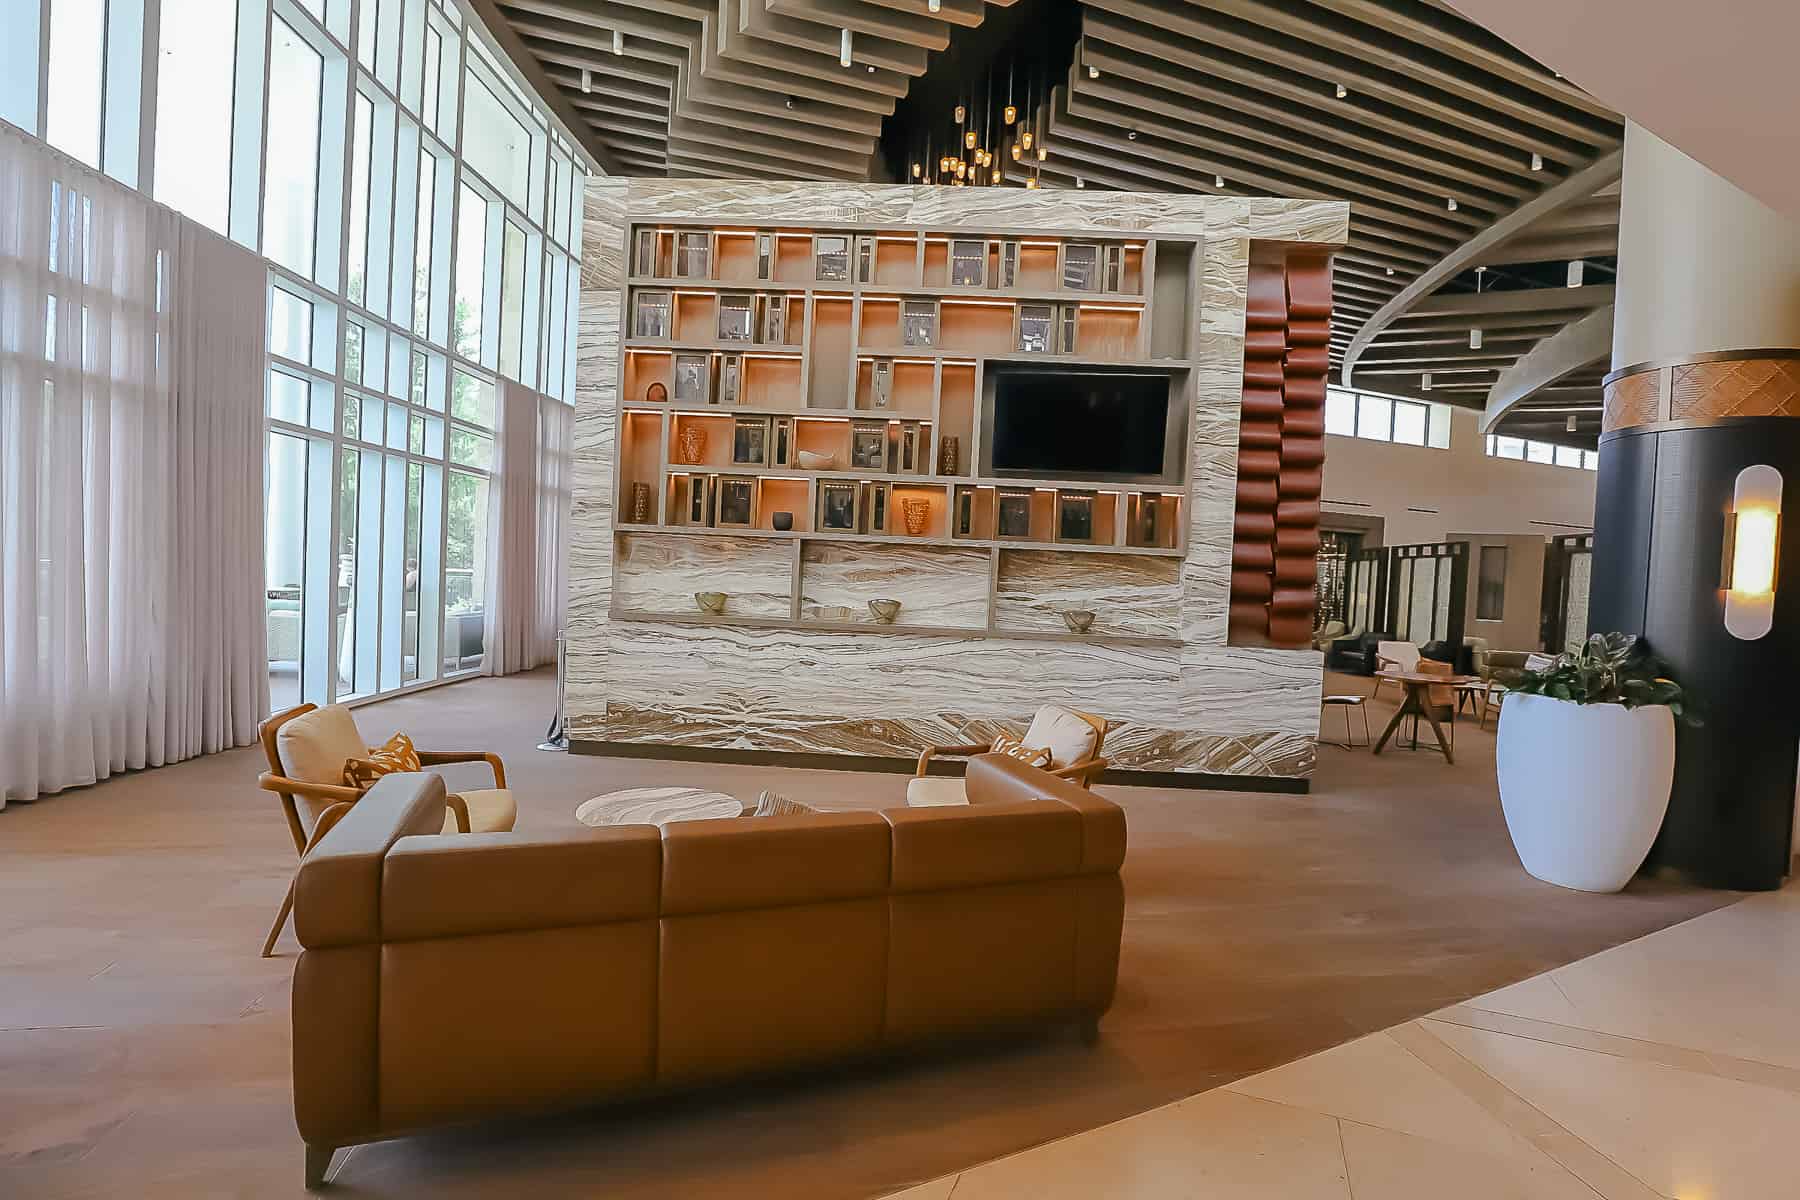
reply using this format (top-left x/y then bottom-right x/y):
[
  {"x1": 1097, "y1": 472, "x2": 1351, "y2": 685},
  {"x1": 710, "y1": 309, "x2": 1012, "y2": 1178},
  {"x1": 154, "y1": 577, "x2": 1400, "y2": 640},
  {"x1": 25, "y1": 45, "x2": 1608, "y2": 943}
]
[{"x1": 662, "y1": 813, "x2": 889, "y2": 916}]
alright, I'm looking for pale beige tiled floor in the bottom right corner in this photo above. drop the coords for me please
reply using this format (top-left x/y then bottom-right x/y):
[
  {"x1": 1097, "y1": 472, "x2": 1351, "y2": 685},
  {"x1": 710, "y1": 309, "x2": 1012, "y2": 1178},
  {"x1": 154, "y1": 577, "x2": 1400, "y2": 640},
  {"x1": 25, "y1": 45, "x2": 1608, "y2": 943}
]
[{"x1": 889, "y1": 885, "x2": 1800, "y2": 1200}]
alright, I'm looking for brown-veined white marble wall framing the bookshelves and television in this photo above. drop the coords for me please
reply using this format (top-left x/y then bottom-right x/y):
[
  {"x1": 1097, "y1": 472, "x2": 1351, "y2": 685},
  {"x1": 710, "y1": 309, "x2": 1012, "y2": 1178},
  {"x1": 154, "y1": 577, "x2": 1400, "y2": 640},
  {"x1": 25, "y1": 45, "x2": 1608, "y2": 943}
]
[{"x1": 567, "y1": 178, "x2": 1348, "y2": 779}]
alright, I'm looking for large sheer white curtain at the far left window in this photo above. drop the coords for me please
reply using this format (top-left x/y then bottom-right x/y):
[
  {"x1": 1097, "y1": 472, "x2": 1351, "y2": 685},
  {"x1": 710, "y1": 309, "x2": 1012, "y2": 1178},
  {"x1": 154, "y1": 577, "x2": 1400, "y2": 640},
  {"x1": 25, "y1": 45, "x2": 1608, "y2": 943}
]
[{"x1": 0, "y1": 124, "x2": 268, "y2": 806}]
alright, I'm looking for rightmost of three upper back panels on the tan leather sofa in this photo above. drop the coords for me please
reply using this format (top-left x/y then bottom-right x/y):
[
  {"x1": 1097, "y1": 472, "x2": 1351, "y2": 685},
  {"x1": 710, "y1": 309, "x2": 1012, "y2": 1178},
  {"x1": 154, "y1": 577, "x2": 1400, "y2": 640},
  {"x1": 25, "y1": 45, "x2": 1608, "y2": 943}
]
[{"x1": 882, "y1": 801, "x2": 1082, "y2": 892}]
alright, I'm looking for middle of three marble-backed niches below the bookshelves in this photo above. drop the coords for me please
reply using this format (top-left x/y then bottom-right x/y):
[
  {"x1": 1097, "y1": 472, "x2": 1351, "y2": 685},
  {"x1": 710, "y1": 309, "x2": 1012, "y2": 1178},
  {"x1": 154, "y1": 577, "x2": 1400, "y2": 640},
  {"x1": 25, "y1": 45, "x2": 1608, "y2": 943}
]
[{"x1": 799, "y1": 542, "x2": 990, "y2": 630}]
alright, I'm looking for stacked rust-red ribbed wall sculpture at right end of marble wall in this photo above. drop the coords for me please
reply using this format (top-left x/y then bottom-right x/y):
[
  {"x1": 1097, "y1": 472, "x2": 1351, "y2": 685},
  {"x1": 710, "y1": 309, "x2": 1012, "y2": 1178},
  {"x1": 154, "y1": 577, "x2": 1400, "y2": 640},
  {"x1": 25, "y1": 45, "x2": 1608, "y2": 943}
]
[{"x1": 1229, "y1": 255, "x2": 1332, "y2": 646}]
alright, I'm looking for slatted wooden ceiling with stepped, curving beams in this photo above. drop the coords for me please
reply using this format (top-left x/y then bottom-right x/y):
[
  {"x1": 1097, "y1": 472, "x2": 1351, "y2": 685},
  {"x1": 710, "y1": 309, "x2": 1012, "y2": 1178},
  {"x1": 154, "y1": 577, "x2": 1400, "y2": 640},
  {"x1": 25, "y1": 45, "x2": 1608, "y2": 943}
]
[{"x1": 493, "y1": 0, "x2": 1624, "y2": 433}]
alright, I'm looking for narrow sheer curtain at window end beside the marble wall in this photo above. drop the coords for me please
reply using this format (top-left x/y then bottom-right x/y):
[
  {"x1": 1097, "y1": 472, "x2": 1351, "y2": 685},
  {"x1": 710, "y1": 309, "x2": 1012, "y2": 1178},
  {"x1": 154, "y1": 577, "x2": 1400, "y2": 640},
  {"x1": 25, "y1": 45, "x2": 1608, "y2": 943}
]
[{"x1": 481, "y1": 380, "x2": 574, "y2": 675}]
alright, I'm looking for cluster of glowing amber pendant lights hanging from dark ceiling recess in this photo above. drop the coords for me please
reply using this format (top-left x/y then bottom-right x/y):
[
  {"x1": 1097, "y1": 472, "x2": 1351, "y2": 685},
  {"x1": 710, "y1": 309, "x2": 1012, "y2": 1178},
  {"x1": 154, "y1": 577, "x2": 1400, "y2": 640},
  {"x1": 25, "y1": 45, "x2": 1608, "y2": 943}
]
[{"x1": 909, "y1": 58, "x2": 1049, "y2": 187}]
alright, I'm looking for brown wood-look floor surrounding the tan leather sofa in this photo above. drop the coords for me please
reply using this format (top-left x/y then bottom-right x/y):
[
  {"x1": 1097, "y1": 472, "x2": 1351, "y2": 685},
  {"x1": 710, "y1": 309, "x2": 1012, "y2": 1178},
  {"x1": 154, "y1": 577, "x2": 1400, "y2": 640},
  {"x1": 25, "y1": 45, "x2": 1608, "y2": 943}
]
[{"x1": 0, "y1": 675, "x2": 1733, "y2": 1200}]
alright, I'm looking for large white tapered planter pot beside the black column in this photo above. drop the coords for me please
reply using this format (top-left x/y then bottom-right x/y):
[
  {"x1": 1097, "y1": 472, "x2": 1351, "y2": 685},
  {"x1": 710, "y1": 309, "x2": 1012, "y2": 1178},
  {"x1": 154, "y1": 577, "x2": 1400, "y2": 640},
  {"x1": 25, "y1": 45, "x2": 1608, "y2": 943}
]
[{"x1": 1496, "y1": 693, "x2": 1676, "y2": 892}]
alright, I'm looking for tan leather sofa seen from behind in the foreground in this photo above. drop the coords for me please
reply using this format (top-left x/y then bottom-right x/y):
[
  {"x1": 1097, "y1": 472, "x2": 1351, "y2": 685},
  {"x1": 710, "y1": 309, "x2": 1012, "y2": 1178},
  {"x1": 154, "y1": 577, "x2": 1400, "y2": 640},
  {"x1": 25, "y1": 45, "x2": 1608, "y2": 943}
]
[{"x1": 293, "y1": 756, "x2": 1125, "y2": 1187}]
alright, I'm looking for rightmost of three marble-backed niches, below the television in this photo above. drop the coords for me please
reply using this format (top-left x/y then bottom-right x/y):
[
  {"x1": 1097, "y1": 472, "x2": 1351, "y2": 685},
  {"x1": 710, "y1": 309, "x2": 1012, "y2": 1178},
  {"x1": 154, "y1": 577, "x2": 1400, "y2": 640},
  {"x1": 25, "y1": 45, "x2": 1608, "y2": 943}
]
[{"x1": 994, "y1": 551, "x2": 1181, "y2": 640}]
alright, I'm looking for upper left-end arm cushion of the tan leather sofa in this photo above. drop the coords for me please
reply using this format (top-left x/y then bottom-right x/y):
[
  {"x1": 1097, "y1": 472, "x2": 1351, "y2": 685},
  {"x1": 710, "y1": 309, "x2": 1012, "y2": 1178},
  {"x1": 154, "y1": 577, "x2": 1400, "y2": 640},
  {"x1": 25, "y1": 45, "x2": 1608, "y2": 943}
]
[{"x1": 293, "y1": 774, "x2": 445, "y2": 950}]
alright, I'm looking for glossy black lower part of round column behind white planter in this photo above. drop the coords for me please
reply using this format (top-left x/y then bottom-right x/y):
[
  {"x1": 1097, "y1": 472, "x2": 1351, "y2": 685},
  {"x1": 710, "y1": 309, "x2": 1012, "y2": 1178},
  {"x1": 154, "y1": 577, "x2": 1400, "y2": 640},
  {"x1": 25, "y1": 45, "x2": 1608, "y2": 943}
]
[{"x1": 1588, "y1": 402, "x2": 1800, "y2": 891}]
